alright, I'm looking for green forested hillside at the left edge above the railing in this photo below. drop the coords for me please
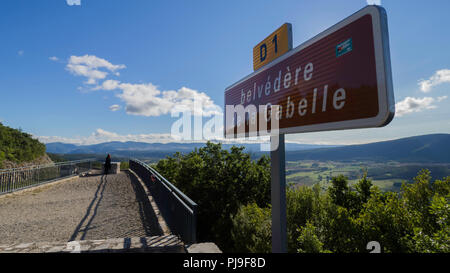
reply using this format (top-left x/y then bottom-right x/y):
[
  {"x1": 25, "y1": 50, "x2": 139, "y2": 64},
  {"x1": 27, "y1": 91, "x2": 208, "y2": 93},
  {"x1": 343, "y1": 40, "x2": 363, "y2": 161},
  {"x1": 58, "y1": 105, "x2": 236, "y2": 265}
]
[{"x1": 0, "y1": 123, "x2": 45, "y2": 168}]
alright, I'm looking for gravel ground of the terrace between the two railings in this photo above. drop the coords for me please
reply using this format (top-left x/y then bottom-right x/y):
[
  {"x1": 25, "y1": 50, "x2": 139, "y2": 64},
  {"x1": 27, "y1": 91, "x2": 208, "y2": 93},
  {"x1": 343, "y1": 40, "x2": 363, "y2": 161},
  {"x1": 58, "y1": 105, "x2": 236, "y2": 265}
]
[{"x1": 0, "y1": 172, "x2": 162, "y2": 244}]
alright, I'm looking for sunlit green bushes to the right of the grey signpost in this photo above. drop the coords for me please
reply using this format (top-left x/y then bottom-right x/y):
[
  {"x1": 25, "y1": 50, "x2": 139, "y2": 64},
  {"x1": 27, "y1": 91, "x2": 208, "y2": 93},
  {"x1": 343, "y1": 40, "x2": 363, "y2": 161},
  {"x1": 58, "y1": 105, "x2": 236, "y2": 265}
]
[{"x1": 244, "y1": 170, "x2": 450, "y2": 253}]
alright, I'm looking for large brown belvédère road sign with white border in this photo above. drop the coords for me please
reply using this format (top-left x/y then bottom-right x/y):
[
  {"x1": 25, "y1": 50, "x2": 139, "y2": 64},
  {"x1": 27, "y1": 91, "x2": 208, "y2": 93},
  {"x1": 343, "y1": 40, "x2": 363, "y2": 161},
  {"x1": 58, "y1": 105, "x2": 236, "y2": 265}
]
[{"x1": 225, "y1": 6, "x2": 395, "y2": 137}]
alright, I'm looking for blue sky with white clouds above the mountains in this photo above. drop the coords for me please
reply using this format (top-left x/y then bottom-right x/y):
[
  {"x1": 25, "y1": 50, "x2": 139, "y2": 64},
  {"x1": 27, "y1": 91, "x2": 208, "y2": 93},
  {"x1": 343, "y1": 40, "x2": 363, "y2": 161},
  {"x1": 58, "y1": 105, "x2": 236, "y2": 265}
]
[{"x1": 0, "y1": 0, "x2": 450, "y2": 144}]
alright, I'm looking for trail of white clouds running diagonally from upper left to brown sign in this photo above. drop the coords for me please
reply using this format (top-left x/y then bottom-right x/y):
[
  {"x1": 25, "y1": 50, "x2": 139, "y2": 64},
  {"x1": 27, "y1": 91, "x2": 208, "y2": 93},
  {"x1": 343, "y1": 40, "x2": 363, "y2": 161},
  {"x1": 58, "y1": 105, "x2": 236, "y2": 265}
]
[{"x1": 66, "y1": 55, "x2": 222, "y2": 117}]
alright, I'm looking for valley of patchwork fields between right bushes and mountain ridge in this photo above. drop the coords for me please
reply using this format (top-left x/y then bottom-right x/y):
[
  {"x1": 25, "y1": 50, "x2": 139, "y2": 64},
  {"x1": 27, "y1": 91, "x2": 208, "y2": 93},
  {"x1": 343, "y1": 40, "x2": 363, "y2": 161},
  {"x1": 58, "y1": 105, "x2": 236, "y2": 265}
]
[{"x1": 286, "y1": 160, "x2": 450, "y2": 191}]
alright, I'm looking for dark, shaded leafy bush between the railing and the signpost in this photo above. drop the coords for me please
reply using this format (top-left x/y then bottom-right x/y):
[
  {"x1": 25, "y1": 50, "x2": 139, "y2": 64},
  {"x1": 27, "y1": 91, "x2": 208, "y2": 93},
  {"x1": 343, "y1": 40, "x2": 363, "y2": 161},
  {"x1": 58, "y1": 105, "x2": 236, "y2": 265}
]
[{"x1": 156, "y1": 142, "x2": 270, "y2": 251}]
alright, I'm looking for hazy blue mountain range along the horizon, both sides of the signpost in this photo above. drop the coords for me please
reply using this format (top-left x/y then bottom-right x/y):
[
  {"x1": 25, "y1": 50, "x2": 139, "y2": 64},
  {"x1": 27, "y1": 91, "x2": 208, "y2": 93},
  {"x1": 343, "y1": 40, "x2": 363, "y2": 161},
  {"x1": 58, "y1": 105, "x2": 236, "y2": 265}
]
[{"x1": 46, "y1": 134, "x2": 450, "y2": 163}]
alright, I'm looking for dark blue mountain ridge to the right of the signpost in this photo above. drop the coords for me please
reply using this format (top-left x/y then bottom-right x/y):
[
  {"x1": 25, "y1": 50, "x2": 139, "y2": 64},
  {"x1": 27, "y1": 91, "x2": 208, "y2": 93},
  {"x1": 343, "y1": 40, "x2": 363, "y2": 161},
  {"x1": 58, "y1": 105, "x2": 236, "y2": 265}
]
[{"x1": 286, "y1": 134, "x2": 450, "y2": 163}]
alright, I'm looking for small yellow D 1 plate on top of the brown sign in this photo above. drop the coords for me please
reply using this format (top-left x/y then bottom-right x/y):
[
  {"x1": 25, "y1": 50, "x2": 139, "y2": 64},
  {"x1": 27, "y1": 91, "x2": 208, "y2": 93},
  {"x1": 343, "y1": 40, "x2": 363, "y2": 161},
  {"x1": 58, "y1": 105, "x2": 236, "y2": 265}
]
[{"x1": 253, "y1": 23, "x2": 292, "y2": 71}]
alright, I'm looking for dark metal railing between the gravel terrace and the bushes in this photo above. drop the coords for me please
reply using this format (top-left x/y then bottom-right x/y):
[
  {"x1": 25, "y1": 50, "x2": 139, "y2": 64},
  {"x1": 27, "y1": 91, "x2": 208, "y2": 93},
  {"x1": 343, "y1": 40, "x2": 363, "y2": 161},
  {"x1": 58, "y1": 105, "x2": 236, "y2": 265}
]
[{"x1": 129, "y1": 159, "x2": 197, "y2": 244}]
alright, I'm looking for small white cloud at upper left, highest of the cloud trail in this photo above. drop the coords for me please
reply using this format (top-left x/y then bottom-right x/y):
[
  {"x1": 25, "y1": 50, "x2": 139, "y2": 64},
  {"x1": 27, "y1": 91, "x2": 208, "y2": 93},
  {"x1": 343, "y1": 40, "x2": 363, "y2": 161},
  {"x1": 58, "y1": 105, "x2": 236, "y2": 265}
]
[{"x1": 66, "y1": 55, "x2": 126, "y2": 85}]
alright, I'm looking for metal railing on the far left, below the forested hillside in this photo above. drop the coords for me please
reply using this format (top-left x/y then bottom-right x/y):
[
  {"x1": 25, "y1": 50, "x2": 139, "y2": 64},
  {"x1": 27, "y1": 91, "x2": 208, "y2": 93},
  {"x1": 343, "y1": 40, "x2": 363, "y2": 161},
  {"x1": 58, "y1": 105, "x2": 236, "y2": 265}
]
[{"x1": 0, "y1": 159, "x2": 95, "y2": 195}]
